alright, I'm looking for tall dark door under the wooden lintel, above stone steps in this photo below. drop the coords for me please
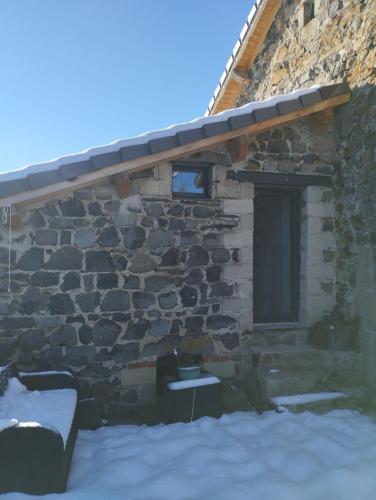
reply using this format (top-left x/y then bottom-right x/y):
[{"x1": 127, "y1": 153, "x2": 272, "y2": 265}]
[{"x1": 253, "y1": 189, "x2": 300, "y2": 323}]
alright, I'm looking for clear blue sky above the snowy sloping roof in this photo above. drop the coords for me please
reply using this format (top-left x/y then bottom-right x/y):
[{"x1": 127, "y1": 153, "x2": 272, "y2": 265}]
[{"x1": 0, "y1": 0, "x2": 253, "y2": 171}]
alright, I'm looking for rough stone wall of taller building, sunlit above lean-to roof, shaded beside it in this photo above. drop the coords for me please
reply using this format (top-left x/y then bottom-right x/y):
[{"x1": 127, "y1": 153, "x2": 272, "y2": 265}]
[{"x1": 238, "y1": 0, "x2": 376, "y2": 383}]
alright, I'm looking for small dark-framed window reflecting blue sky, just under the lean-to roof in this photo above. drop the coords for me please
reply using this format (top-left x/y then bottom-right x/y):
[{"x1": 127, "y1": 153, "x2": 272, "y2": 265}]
[{"x1": 172, "y1": 164, "x2": 210, "y2": 198}]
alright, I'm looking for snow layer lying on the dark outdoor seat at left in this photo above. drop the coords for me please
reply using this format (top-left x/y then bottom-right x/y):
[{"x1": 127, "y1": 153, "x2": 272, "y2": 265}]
[{"x1": 0, "y1": 378, "x2": 77, "y2": 446}]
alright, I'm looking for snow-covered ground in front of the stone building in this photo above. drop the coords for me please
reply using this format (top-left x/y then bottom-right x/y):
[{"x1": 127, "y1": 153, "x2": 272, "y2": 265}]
[{"x1": 2, "y1": 410, "x2": 376, "y2": 500}]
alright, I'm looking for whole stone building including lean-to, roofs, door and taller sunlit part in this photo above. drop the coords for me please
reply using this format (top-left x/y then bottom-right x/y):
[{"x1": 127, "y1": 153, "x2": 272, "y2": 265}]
[{"x1": 0, "y1": 0, "x2": 376, "y2": 414}]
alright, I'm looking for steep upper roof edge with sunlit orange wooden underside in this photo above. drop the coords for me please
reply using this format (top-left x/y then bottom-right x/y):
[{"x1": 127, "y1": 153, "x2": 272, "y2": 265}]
[{"x1": 206, "y1": 0, "x2": 282, "y2": 115}]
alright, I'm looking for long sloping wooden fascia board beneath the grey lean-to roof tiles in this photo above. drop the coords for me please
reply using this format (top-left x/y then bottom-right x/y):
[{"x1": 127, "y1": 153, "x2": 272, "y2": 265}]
[{"x1": 0, "y1": 93, "x2": 351, "y2": 206}]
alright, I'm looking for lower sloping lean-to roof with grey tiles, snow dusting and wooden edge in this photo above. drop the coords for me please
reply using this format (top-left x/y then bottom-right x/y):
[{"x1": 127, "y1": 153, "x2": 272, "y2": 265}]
[{"x1": 0, "y1": 84, "x2": 349, "y2": 206}]
